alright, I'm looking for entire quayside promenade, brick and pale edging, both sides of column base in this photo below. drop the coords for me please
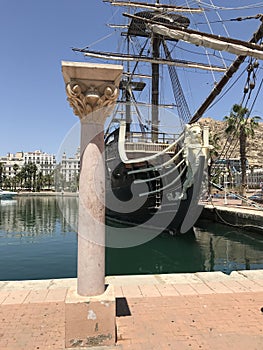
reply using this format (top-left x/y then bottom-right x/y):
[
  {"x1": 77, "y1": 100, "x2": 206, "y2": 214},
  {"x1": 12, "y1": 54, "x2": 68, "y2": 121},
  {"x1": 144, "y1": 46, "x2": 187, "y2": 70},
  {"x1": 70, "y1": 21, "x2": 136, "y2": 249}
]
[{"x1": 0, "y1": 270, "x2": 263, "y2": 350}]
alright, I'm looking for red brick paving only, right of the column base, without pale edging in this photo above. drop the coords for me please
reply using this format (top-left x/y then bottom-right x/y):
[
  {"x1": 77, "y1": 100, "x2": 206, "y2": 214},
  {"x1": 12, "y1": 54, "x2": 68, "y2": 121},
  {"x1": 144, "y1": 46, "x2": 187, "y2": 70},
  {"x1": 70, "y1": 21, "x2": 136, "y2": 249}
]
[{"x1": 117, "y1": 292, "x2": 263, "y2": 350}]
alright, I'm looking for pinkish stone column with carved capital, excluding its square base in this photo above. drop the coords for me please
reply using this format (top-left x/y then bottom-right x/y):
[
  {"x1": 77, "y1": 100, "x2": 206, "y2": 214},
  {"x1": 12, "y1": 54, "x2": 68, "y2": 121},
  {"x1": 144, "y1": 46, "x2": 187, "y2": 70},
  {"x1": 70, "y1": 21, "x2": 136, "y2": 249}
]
[{"x1": 62, "y1": 62, "x2": 123, "y2": 296}]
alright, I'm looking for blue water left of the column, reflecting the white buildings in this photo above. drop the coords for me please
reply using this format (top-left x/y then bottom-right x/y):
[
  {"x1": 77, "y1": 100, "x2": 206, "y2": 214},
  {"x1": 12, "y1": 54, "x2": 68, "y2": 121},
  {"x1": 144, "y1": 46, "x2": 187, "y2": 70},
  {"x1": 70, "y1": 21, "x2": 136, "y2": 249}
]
[{"x1": 0, "y1": 197, "x2": 77, "y2": 280}]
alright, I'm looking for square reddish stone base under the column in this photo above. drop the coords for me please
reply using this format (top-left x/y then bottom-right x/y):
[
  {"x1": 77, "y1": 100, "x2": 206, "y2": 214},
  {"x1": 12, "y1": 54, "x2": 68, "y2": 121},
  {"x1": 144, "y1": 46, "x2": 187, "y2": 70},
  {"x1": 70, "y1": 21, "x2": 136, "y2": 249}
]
[{"x1": 65, "y1": 285, "x2": 116, "y2": 349}]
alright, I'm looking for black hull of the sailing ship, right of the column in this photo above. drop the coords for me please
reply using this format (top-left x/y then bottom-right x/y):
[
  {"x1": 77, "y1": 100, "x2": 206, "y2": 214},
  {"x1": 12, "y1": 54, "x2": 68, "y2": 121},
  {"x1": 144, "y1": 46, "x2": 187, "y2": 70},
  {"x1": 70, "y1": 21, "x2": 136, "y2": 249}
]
[{"x1": 106, "y1": 142, "x2": 205, "y2": 235}]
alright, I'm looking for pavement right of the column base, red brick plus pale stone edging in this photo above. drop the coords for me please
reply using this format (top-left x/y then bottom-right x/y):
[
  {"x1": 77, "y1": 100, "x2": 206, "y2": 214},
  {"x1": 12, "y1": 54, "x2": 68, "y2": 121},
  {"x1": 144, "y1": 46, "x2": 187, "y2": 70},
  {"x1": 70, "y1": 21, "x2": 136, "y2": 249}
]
[{"x1": 109, "y1": 271, "x2": 263, "y2": 350}]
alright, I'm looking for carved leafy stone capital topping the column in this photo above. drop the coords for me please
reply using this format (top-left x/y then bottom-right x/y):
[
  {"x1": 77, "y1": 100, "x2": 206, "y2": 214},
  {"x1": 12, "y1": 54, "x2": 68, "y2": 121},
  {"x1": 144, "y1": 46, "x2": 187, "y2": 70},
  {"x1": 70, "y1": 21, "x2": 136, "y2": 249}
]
[{"x1": 62, "y1": 62, "x2": 122, "y2": 124}]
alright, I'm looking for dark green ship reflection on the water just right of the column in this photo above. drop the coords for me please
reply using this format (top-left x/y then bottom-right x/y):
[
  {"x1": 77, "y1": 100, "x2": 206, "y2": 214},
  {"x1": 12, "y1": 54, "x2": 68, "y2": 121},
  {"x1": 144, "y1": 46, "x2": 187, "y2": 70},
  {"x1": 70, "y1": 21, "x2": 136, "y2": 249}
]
[{"x1": 106, "y1": 231, "x2": 205, "y2": 275}]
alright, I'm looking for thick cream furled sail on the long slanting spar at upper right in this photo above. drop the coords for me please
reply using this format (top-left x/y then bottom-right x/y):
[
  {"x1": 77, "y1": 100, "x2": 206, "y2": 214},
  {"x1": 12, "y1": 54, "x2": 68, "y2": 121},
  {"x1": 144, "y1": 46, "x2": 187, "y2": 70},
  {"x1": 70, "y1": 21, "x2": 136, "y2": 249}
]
[{"x1": 152, "y1": 24, "x2": 263, "y2": 59}]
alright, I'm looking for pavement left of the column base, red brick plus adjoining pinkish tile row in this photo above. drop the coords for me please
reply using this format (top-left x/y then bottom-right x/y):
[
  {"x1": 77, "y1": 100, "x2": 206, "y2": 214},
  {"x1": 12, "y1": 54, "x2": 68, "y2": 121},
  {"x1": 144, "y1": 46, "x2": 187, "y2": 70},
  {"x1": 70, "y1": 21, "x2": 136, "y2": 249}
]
[{"x1": 0, "y1": 288, "x2": 67, "y2": 350}]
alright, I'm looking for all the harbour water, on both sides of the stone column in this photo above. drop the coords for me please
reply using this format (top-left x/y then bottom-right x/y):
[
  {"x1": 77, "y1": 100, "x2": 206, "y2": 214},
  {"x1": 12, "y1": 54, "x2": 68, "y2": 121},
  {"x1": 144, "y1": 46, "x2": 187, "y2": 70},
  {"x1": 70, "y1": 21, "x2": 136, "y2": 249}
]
[{"x1": 0, "y1": 197, "x2": 263, "y2": 280}]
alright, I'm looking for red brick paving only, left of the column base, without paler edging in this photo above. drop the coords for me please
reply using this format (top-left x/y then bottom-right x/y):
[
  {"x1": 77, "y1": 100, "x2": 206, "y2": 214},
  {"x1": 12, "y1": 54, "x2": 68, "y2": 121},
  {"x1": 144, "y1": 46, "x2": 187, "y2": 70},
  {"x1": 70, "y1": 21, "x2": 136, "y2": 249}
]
[{"x1": 0, "y1": 302, "x2": 65, "y2": 350}]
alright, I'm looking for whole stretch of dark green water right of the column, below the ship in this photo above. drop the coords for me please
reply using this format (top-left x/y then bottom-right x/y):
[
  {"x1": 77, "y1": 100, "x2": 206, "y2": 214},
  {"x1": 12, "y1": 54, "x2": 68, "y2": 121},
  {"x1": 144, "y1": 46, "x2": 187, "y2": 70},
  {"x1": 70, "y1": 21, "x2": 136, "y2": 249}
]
[{"x1": 106, "y1": 222, "x2": 263, "y2": 274}]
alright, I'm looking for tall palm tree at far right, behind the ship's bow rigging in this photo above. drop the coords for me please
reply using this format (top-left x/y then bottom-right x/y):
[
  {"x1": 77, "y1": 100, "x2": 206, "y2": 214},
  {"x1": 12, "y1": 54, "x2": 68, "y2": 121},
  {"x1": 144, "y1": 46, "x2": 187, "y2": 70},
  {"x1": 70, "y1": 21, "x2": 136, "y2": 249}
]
[{"x1": 224, "y1": 104, "x2": 261, "y2": 195}]
